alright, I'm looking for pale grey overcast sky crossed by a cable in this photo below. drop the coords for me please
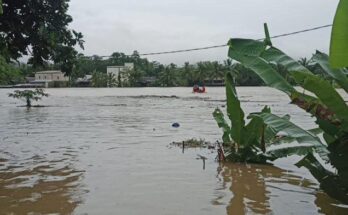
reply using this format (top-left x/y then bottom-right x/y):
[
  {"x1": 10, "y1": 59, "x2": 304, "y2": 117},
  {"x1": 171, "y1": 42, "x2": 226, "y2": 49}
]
[{"x1": 69, "y1": 0, "x2": 338, "y2": 64}]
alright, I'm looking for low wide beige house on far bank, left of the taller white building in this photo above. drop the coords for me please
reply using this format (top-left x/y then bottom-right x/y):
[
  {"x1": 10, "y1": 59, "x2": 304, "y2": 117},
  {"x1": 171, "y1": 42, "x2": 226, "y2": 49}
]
[{"x1": 30, "y1": 70, "x2": 69, "y2": 87}]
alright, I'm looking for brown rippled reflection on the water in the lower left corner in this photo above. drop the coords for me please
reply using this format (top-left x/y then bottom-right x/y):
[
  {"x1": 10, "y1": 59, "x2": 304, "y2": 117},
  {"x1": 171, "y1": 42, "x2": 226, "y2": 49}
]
[{"x1": 0, "y1": 149, "x2": 86, "y2": 214}]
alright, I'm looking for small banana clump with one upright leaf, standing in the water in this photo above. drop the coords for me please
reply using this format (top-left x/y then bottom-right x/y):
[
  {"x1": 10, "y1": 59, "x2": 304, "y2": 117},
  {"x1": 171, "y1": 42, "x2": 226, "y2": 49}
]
[{"x1": 213, "y1": 72, "x2": 327, "y2": 163}]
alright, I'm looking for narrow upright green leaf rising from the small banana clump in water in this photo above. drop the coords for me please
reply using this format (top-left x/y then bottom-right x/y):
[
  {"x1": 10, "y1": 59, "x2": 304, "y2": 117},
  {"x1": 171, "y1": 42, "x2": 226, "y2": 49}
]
[{"x1": 225, "y1": 72, "x2": 245, "y2": 144}]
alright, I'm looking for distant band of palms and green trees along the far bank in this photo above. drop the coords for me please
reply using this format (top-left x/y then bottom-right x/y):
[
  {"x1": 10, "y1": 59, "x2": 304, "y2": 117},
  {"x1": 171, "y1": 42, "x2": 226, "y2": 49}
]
[{"x1": 67, "y1": 51, "x2": 263, "y2": 87}]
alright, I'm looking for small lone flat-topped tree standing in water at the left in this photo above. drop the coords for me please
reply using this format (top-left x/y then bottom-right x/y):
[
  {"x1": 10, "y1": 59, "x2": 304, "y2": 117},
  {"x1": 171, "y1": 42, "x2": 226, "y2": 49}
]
[{"x1": 8, "y1": 88, "x2": 48, "y2": 108}]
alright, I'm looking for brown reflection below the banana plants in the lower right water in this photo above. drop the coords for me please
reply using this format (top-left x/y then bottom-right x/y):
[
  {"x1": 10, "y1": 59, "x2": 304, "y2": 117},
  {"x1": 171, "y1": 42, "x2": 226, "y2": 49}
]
[{"x1": 217, "y1": 164, "x2": 347, "y2": 215}]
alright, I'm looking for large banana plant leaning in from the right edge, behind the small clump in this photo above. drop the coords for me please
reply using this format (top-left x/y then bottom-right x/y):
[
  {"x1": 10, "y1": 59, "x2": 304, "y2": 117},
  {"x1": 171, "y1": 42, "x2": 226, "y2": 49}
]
[{"x1": 228, "y1": 19, "x2": 348, "y2": 203}]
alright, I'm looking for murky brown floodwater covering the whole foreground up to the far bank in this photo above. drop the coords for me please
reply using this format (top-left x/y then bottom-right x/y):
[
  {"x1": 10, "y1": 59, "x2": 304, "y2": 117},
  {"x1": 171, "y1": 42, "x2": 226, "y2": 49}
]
[{"x1": 0, "y1": 87, "x2": 348, "y2": 215}]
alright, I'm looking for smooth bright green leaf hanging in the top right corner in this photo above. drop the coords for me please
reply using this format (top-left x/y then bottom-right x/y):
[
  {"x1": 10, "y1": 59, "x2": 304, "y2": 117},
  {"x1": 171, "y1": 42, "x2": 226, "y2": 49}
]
[{"x1": 330, "y1": 0, "x2": 348, "y2": 68}]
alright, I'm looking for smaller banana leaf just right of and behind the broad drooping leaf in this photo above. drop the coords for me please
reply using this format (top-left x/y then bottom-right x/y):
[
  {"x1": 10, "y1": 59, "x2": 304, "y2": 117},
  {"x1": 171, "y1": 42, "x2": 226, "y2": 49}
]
[{"x1": 261, "y1": 47, "x2": 310, "y2": 73}]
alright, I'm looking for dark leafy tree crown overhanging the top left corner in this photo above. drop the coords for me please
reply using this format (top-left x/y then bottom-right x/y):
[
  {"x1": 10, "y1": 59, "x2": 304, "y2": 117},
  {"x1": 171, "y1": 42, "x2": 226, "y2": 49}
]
[{"x1": 0, "y1": 0, "x2": 84, "y2": 74}]
